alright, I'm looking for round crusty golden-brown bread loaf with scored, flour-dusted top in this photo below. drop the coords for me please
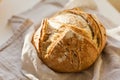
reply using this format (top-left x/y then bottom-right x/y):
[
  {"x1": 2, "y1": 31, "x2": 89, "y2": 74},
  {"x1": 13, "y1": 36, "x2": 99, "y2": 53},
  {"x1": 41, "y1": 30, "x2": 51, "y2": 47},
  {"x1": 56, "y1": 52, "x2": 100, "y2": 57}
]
[{"x1": 32, "y1": 8, "x2": 106, "y2": 72}]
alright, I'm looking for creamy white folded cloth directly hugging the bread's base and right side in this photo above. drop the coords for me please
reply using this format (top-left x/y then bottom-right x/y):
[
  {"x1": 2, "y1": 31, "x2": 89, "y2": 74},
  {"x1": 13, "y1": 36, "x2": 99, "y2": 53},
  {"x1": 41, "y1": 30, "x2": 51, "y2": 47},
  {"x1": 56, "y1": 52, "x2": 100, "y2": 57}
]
[{"x1": 21, "y1": 0, "x2": 120, "y2": 80}]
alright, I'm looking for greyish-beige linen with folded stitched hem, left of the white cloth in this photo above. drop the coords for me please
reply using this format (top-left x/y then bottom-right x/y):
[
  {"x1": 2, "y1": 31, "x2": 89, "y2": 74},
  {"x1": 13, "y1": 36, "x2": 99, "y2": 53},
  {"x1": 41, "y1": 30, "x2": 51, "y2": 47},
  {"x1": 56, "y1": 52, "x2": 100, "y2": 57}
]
[{"x1": 0, "y1": 16, "x2": 32, "y2": 80}]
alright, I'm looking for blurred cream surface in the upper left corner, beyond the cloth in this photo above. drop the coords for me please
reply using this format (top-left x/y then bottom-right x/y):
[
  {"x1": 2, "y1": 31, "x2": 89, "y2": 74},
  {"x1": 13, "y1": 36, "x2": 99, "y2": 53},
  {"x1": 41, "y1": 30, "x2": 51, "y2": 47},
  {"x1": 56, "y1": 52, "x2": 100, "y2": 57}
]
[{"x1": 0, "y1": 0, "x2": 40, "y2": 45}]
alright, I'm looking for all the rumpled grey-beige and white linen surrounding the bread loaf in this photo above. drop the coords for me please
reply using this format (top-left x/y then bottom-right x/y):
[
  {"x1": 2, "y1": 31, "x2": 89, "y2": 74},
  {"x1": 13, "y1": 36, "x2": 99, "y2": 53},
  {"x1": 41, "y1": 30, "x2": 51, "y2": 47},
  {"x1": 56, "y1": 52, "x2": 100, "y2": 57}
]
[{"x1": 0, "y1": 0, "x2": 120, "y2": 80}]
